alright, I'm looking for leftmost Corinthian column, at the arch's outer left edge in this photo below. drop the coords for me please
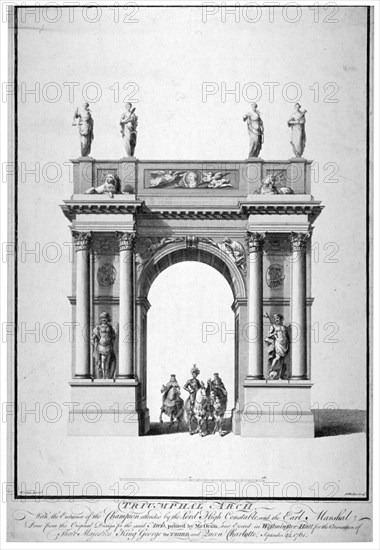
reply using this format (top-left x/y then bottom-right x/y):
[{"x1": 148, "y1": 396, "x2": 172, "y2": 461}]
[{"x1": 73, "y1": 231, "x2": 91, "y2": 378}]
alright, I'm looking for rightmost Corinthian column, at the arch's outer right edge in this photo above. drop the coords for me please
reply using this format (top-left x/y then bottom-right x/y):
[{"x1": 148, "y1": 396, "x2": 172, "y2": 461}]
[{"x1": 290, "y1": 233, "x2": 310, "y2": 380}]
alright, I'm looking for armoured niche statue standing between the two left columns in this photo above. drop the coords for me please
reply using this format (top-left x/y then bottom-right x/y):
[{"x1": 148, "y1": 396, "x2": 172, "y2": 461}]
[{"x1": 92, "y1": 312, "x2": 116, "y2": 378}]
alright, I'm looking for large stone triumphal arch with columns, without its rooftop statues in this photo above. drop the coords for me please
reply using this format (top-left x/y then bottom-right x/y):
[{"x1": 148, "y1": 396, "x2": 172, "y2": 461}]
[{"x1": 62, "y1": 156, "x2": 322, "y2": 437}]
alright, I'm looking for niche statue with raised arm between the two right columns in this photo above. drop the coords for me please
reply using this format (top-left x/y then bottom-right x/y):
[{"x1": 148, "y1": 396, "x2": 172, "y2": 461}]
[{"x1": 265, "y1": 313, "x2": 290, "y2": 380}]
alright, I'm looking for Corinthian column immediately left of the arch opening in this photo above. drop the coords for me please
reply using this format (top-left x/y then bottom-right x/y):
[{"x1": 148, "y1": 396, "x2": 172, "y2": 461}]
[{"x1": 118, "y1": 233, "x2": 135, "y2": 378}]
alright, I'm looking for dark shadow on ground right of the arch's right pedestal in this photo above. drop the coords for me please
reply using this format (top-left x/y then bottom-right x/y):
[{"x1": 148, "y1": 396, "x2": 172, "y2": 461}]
[{"x1": 313, "y1": 409, "x2": 367, "y2": 437}]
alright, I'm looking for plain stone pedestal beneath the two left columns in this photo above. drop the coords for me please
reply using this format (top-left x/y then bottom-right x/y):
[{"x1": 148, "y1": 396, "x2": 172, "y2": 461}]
[{"x1": 68, "y1": 379, "x2": 142, "y2": 436}]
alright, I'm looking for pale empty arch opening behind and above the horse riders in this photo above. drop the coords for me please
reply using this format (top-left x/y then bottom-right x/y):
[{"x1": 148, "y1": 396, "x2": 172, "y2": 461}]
[{"x1": 146, "y1": 255, "x2": 237, "y2": 433}]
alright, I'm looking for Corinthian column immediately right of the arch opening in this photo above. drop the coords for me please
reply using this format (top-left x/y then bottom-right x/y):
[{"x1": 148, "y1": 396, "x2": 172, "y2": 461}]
[{"x1": 247, "y1": 232, "x2": 265, "y2": 380}]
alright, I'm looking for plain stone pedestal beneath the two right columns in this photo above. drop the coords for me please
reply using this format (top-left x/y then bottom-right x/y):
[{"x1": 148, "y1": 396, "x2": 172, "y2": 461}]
[{"x1": 239, "y1": 379, "x2": 314, "y2": 438}]
